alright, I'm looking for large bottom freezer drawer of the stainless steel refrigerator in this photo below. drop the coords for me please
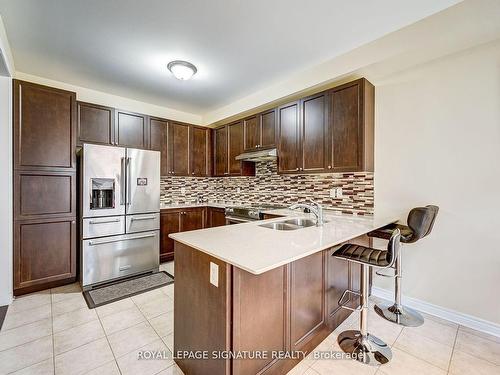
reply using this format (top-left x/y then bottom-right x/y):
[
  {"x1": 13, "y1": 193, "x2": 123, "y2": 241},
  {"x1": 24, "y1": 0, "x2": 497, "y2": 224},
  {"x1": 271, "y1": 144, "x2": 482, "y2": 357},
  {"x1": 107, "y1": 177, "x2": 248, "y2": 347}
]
[{"x1": 82, "y1": 231, "x2": 160, "y2": 289}]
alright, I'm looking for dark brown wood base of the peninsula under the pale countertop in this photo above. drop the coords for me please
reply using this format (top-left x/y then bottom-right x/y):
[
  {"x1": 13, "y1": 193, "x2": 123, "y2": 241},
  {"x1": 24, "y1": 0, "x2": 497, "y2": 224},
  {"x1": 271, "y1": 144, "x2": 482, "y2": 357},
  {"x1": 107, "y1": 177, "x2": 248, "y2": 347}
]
[{"x1": 174, "y1": 238, "x2": 365, "y2": 375}]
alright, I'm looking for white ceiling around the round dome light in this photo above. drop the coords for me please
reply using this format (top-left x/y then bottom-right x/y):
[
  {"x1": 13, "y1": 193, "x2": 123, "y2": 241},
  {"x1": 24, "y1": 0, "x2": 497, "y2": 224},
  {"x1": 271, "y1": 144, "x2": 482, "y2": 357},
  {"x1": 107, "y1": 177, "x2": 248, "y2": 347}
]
[{"x1": 0, "y1": 0, "x2": 460, "y2": 114}]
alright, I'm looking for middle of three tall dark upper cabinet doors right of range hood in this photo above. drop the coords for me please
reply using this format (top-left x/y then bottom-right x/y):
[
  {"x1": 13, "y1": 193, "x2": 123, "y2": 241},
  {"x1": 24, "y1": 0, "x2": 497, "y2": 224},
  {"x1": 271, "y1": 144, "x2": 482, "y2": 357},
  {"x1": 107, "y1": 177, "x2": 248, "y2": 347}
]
[{"x1": 300, "y1": 93, "x2": 328, "y2": 172}]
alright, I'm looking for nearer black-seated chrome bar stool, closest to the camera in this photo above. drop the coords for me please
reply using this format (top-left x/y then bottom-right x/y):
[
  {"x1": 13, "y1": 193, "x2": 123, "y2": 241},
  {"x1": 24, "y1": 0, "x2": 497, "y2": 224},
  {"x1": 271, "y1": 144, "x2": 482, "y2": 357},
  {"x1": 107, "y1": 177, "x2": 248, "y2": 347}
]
[{"x1": 332, "y1": 229, "x2": 401, "y2": 366}]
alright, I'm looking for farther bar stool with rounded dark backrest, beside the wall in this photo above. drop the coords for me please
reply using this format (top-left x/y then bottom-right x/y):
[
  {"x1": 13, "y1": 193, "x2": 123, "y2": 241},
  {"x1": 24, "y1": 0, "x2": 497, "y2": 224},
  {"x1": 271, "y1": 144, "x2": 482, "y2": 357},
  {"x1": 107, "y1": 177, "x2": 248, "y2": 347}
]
[{"x1": 368, "y1": 205, "x2": 439, "y2": 327}]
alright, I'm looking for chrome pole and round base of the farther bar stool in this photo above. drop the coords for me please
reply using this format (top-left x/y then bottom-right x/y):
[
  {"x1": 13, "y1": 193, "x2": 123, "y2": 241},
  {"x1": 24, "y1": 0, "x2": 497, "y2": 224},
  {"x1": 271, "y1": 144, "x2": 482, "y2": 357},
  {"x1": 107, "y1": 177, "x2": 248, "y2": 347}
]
[{"x1": 375, "y1": 246, "x2": 424, "y2": 327}]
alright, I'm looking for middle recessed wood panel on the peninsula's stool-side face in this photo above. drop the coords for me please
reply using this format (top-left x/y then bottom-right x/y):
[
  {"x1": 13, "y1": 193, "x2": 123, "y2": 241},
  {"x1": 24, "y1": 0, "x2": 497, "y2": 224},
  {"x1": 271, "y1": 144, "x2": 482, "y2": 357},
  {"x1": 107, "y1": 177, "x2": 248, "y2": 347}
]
[{"x1": 290, "y1": 252, "x2": 326, "y2": 350}]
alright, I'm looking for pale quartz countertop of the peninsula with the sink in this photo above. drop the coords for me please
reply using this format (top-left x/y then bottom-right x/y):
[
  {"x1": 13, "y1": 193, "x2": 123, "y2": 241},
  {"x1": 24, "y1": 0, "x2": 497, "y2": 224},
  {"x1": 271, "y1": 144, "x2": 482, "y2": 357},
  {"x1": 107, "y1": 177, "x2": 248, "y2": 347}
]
[{"x1": 169, "y1": 209, "x2": 397, "y2": 275}]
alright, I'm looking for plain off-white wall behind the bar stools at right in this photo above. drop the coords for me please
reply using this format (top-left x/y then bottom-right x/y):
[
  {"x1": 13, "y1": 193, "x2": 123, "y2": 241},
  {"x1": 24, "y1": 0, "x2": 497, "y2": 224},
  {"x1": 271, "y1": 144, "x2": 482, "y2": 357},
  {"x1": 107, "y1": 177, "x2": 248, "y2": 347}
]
[{"x1": 374, "y1": 41, "x2": 500, "y2": 324}]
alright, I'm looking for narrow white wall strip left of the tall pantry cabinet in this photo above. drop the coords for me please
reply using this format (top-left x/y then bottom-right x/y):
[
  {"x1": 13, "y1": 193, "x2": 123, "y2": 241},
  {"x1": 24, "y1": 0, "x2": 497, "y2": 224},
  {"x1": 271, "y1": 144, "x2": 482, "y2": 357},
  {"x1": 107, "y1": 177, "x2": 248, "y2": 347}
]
[{"x1": 0, "y1": 77, "x2": 12, "y2": 306}]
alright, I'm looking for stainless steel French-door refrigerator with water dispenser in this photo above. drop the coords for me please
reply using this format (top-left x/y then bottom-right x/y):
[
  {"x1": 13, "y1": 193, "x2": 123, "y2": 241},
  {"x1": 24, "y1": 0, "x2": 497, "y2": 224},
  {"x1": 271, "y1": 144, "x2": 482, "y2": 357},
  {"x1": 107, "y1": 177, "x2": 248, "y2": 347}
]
[{"x1": 80, "y1": 144, "x2": 160, "y2": 290}]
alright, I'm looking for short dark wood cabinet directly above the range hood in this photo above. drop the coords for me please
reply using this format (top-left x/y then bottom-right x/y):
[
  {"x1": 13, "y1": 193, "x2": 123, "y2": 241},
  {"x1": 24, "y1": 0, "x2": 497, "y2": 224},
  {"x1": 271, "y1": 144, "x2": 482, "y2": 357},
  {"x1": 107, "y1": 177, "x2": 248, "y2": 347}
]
[{"x1": 243, "y1": 109, "x2": 276, "y2": 151}]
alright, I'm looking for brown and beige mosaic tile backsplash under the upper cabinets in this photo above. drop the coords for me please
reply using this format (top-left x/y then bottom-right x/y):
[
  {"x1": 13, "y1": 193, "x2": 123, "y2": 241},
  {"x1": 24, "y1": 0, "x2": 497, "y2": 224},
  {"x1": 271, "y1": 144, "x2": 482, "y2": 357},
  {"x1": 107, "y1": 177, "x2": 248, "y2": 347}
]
[{"x1": 161, "y1": 161, "x2": 373, "y2": 215}]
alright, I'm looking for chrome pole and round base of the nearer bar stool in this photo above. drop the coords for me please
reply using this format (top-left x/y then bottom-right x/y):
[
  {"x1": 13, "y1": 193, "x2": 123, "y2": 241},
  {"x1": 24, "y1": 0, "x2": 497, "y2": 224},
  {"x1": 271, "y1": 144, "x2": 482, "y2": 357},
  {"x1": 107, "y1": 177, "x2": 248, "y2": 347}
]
[{"x1": 337, "y1": 264, "x2": 392, "y2": 366}]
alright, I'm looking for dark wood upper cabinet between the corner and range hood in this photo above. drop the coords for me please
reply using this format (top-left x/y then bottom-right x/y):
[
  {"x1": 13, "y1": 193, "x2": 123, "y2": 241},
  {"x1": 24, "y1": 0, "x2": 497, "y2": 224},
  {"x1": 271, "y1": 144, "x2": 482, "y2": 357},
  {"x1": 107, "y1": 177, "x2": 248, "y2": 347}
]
[{"x1": 214, "y1": 121, "x2": 255, "y2": 177}]
